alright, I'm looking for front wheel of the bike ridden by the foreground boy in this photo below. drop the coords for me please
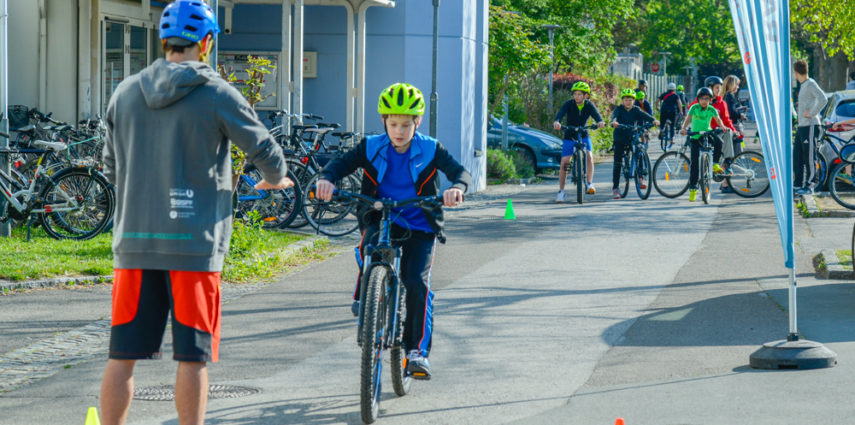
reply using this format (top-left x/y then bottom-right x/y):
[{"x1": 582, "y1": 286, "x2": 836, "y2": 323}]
[{"x1": 359, "y1": 266, "x2": 388, "y2": 424}]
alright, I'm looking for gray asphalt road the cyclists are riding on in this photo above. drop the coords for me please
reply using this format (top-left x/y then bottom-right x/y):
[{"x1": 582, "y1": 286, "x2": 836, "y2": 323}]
[{"x1": 0, "y1": 147, "x2": 852, "y2": 425}]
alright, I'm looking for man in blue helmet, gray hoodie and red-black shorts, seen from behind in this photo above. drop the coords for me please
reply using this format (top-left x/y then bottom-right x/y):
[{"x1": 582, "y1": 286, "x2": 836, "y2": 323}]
[{"x1": 101, "y1": 0, "x2": 293, "y2": 425}]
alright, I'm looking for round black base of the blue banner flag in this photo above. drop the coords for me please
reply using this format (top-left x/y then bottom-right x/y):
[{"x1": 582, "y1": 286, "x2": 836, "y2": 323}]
[{"x1": 749, "y1": 339, "x2": 837, "y2": 369}]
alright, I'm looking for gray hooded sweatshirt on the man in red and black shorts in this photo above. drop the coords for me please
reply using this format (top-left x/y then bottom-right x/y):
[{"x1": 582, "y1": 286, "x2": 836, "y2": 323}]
[{"x1": 104, "y1": 59, "x2": 287, "y2": 272}]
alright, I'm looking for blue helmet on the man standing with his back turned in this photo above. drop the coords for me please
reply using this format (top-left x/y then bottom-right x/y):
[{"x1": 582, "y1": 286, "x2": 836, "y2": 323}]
[{"x1": 160, "y1": 0, "x2": 220, "y2": 46}]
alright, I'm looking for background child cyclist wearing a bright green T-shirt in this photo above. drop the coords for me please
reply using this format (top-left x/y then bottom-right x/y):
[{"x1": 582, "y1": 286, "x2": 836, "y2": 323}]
[{"x1": 680, "y1": 87, "x2": 729, "y2": 202}]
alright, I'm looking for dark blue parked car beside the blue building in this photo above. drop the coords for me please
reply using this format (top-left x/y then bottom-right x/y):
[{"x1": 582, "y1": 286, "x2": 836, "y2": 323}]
[{"x1": 487, "y1": 117, "x2": 562, "y2": 173}]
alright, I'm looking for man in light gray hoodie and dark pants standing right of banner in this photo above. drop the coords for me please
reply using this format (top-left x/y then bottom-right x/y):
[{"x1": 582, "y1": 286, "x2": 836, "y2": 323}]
[{"x1": 793, "y1": 60, "x2": 828, "y2": 195}]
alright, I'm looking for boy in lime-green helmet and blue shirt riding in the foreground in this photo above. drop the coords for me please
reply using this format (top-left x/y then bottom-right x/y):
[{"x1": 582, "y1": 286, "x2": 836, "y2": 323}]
[{"x1": 316, "y1": 83, "x2": 472, "y2": 379}]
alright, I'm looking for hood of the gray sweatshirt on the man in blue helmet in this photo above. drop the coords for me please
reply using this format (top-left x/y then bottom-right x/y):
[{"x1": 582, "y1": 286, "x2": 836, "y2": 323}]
[{"x1": 140, "y1": 59, "x2": 219, "y2": 109}]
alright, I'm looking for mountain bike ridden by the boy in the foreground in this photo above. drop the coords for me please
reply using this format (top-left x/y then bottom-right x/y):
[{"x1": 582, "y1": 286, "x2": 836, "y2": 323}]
[{"x1": 326, "y1": 190, "x2": 442, "y2": 424}]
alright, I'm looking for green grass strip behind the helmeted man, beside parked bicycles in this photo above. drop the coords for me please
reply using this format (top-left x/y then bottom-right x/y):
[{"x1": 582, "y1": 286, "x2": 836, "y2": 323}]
[{"x1": 0, "y1": 223, "x2": 327, "y2": 282}]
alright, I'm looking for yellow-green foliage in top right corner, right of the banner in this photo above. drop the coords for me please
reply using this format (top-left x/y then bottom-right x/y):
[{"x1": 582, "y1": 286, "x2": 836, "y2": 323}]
[{"x1": 790, "y1": 0, "x2": 855, "y2": 61}]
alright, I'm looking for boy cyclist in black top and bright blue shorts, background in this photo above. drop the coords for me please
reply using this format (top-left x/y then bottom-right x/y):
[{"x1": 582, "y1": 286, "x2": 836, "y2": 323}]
[{"x1": 552, "y1": 81, "x2": 606, "y2": 203}]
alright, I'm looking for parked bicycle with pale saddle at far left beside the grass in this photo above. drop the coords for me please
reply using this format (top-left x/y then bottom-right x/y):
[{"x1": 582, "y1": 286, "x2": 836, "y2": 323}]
[{"x1": 0, "y1": 133, "x2": 116, "y2": 240}]
